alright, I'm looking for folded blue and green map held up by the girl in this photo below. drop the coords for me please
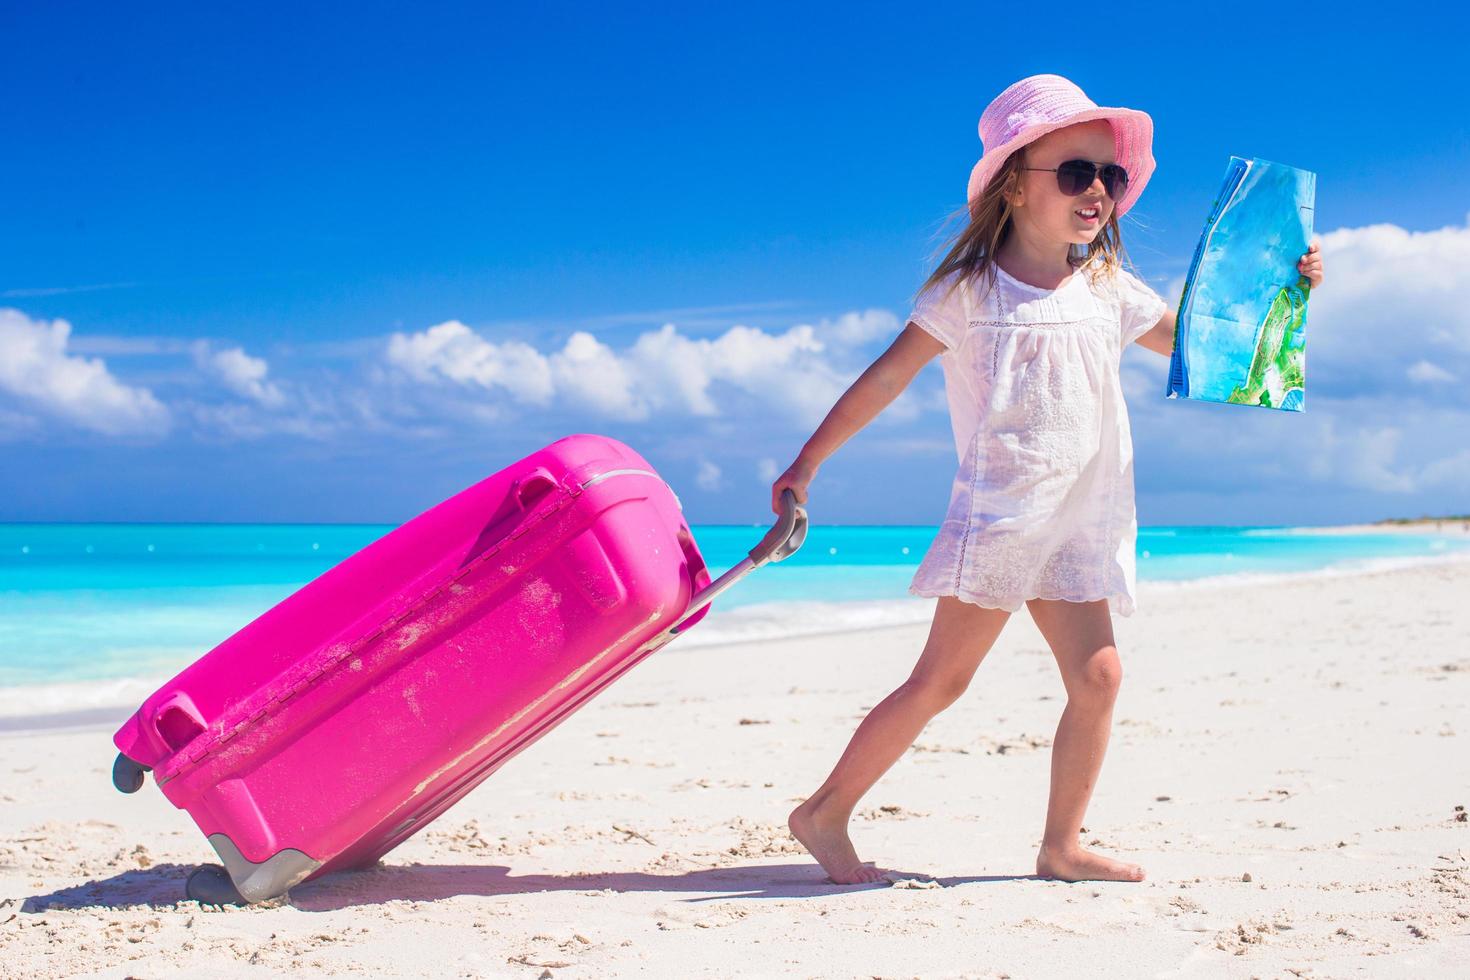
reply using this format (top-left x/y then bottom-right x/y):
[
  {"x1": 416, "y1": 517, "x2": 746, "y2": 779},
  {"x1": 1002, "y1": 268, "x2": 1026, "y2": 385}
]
[{"x1": 1166, "y1": 156, "x2": 1317, "y2": 411}]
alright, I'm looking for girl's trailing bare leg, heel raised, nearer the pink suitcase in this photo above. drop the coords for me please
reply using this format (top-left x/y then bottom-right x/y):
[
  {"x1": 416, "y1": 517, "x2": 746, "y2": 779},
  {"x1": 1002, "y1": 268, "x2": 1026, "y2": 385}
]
[{"x1": 786, "y1": 595, "x2": 1010, "y2": 884}]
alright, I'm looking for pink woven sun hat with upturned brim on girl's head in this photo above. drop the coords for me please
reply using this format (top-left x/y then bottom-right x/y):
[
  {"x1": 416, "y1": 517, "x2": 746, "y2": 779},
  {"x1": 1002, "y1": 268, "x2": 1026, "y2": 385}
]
[{"x1": 969, "y1": 75, "x2": 1154, "y2": 217}]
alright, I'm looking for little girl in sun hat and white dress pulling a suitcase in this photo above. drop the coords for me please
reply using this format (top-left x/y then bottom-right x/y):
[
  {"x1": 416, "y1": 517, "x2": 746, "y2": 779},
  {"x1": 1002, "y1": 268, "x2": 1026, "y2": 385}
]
[{"x1": 772, "y1": 75, "x2": 1323, "y2": 884}]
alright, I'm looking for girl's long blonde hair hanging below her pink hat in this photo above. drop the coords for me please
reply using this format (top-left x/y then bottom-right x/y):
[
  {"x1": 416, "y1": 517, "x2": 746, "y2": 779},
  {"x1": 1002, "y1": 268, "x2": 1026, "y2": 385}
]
[{"x1": 914, "y1": 147, "x2": 1132, "y2": 308}]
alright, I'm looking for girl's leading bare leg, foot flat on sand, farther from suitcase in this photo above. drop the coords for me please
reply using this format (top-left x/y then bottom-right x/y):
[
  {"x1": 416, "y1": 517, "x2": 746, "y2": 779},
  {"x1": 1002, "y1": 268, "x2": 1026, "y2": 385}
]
[{"x1": 1026, "y1": 599, "x2": 1144, "y2": 882}]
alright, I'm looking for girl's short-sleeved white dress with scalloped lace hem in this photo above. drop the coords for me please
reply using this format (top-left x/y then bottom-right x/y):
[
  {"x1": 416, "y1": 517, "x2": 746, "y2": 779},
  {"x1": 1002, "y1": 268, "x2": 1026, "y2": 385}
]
[{"x1": 908, "y1": 266, "x2": 1169, "y2": 616}]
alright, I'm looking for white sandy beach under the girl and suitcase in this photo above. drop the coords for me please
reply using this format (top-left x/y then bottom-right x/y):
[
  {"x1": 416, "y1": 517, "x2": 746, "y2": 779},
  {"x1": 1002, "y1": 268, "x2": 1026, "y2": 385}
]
[{"x1": 0, "y1": 561, "x2": 1470, "y2": 977}]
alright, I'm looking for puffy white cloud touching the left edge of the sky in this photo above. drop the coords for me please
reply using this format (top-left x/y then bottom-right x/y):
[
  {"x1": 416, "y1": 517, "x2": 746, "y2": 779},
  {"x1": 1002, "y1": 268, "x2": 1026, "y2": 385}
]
[{"x1": 0, "y1": 309, "x2": 171, "y2": 436}]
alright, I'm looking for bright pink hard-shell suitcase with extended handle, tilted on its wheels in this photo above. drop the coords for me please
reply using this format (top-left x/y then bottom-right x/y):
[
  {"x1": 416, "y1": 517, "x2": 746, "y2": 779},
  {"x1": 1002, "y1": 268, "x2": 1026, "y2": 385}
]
[{"x1": 113, "y1": 435, "x2": 807, "y2": 902}]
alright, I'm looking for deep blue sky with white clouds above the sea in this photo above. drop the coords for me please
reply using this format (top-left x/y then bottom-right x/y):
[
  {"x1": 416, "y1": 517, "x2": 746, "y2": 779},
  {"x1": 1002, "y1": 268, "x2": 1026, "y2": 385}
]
[{"x1": 0, "y1": 3, "x2": 1470, "y2": 525}]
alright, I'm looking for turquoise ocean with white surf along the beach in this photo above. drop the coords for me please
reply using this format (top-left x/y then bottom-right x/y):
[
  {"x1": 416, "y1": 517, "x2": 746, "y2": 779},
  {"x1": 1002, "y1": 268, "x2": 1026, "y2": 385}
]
[{"x1": 0, "y1": 525, "x2": 1470, "y2": 714}]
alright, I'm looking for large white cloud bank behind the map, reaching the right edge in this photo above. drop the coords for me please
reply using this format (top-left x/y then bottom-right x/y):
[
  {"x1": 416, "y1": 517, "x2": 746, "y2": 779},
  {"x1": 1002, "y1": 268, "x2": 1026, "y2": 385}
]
[{"x1": 1123, "y1": 213, "x2": 1470, "y2": 511}]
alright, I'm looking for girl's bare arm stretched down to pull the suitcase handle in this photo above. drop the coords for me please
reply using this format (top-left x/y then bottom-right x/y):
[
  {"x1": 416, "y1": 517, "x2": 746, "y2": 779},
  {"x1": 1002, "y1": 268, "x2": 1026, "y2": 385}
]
[{"x1": 770, "y1": 322, "x2": 944, "y2": 514}]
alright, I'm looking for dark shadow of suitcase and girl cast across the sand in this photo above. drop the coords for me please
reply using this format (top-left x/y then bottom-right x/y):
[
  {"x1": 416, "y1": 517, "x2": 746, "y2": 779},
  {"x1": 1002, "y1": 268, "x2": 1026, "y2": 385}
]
[{"x1": 21, "y1": 862, "x2": 1041, "y2": 912}]
